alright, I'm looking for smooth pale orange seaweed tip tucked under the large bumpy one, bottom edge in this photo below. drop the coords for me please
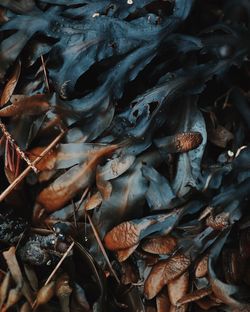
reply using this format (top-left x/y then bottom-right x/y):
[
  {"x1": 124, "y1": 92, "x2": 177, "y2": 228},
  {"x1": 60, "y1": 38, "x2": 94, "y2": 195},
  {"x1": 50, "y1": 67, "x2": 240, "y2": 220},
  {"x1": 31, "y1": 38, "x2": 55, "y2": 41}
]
[{"x1": 168, "y1": 271, "x2": 189, "y2": 306}]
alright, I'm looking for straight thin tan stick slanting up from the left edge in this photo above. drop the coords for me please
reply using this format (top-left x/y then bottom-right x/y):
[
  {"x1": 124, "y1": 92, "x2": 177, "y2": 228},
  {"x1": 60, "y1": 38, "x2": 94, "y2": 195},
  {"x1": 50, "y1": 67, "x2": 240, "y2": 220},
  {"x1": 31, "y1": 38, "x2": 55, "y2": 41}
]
[{"x1": 0, "y1": 130, "x2": 66, "y2": 202}]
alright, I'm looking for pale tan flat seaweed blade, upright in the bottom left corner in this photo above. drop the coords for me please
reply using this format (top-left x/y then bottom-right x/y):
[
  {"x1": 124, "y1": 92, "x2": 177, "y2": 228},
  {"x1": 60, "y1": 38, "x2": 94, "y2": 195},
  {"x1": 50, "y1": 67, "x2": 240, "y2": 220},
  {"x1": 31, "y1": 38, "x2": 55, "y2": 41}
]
[{"x1": 3, "y1": 247, "x2": 34, "y2": 305}]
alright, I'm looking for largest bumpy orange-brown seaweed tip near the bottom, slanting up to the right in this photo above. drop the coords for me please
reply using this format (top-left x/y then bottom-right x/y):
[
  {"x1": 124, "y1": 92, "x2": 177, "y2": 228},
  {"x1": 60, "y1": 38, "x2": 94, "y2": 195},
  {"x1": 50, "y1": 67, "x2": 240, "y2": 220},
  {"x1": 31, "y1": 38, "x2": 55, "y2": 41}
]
[{"x1": 144, "y1": 253, "x2": 191, "y2": 299}]
